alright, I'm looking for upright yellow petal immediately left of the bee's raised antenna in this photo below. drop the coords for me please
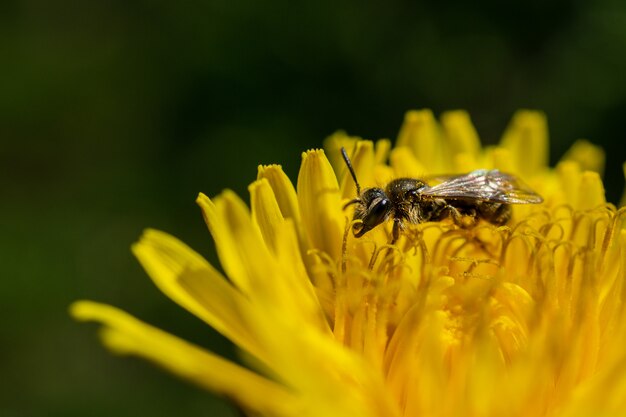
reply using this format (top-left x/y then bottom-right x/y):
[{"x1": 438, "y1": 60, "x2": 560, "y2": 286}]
[{"x1": 297, "y1": 150, "x2": 346, "y2": 259}]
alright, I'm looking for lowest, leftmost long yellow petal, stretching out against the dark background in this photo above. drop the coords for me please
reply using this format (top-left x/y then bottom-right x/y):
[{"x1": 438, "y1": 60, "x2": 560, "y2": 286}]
[{"x1": 70, "y1": 301, "x2": 301, "y2": 417}]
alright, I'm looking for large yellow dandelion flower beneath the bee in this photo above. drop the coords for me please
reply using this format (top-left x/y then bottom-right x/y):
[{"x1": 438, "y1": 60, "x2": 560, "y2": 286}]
[{"x1": 71, "y1": 111, "x2": 626, "y2": 417}]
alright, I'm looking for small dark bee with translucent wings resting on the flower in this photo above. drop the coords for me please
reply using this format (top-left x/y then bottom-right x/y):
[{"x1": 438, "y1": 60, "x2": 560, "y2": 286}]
[{"x1": 341, "y1": 147, "x2": 543, "y2": 244}]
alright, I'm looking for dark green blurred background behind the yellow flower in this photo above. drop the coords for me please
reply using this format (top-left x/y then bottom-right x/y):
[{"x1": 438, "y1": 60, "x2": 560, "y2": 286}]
[{"x1": 0, "y1": 0, "x2": 626, "y2": 416}]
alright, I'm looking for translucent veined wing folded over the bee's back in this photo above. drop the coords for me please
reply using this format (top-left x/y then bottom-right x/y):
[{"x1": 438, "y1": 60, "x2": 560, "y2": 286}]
[{"x1": 421, "y1": 169, "x2": 543, "y2": 204}]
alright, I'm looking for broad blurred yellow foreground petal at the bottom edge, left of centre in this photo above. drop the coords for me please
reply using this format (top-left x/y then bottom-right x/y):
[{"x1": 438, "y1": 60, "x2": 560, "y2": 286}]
[{"x1": 243, "y1": 306, "x2": 398, "y2": 417}]
